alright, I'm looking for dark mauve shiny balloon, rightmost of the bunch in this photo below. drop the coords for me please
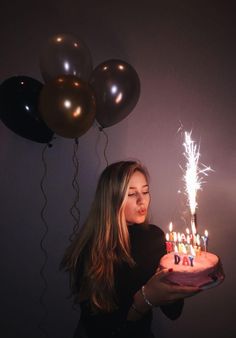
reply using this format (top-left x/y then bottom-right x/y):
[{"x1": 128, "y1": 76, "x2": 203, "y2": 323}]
[{"x1": 90, "y1": 60, "x2": 140, "y2": 128}]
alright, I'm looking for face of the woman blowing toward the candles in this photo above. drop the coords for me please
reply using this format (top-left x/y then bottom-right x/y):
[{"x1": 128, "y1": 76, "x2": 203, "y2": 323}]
[{"x1": 124, "y1": 171, "x2": 150, "y2": 224}]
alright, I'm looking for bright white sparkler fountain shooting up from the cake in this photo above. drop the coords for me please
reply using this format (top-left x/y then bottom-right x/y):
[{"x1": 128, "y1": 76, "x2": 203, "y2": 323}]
[{"x1": 183, "y1": 132, "x2": 212, "y2": 238}]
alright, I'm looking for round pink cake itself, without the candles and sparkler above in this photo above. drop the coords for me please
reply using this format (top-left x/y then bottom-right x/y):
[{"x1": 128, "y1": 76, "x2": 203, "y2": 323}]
[{"x1": 160, "y1": 252, "x2": 221, "y2": 287}]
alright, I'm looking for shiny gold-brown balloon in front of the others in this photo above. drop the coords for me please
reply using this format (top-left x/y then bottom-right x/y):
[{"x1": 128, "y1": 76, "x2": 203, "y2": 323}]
[{"x1": 39, "y1": 75, "x2": 95, "y2": 138}]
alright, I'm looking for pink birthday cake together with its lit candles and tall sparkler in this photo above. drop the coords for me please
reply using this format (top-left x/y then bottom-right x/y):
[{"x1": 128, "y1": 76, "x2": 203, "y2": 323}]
[{"x1": 160, "y1": 132, "x2": 224, "y2": 289}]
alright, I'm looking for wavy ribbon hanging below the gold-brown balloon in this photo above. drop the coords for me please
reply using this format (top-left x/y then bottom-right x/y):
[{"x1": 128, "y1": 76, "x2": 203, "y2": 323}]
[{"x1": 69, "y1": 138, "x2": 80, "y2": 242}]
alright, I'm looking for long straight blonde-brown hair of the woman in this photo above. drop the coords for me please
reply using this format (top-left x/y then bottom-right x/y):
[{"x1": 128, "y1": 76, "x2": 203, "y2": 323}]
[{"x1": 61, "y1": 161, "x2": 149, "y2": 312}]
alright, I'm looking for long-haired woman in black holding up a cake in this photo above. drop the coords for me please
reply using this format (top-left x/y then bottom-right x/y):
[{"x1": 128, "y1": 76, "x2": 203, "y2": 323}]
[{"x1": 62, "y1": 161, "x2": 199, "y2": 338}]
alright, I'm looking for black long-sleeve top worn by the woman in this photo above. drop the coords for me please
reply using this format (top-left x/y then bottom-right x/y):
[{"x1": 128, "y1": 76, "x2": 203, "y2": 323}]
[{"x1": 74, "y1": 224, "x2": 183, "y2": 338}]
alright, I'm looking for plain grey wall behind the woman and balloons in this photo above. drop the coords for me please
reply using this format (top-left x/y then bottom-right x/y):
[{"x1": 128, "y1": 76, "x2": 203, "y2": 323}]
[{"x1": 0, "y1": 0, "x2": 236, "y2": 338}]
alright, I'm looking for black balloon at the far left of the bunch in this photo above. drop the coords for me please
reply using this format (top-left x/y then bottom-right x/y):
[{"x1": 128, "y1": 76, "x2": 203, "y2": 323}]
[{"x1": 0, "y1": 76, "x2": 53, "y2": 143}]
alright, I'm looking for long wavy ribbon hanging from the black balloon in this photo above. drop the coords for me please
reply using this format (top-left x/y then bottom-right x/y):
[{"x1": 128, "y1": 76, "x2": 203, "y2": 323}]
[{"x1": 38, "y1": 144, "x2": 51, "y2": 337}]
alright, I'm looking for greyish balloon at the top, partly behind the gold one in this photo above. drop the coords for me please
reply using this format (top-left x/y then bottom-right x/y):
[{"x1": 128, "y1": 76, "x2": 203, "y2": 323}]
[{"x1": 39, "y1": 34, "x2": 93, "y2": 82}]
